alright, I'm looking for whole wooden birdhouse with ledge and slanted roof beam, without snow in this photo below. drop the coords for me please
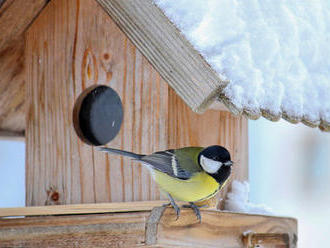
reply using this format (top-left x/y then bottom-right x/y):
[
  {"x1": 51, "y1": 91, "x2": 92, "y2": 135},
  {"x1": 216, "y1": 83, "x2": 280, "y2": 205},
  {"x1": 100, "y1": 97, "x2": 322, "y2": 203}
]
[{"x1": 0, "y1": 0, "x2": 310, "y2": 247}]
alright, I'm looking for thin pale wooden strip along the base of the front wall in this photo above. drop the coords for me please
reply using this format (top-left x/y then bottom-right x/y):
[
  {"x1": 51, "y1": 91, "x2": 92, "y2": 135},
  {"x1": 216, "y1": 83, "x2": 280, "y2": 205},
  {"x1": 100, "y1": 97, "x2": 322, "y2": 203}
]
[{"x1": 0, "y1": 201, "x2": 168, "y2": 218}]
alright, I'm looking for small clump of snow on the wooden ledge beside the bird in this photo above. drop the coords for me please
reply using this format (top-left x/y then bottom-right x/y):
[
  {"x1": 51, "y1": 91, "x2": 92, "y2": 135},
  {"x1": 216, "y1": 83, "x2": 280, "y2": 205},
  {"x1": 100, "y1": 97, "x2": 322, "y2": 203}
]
[{"x1": 225, "y1": 181, "x2": 272, "y2": 214}]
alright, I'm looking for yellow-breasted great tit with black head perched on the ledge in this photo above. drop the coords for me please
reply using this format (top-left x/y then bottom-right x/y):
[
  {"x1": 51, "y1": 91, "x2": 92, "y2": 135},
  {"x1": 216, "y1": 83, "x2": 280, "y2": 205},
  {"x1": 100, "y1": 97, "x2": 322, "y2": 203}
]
[{"x1": 99, "y1": 145, "x2": 233, "y2": 221}]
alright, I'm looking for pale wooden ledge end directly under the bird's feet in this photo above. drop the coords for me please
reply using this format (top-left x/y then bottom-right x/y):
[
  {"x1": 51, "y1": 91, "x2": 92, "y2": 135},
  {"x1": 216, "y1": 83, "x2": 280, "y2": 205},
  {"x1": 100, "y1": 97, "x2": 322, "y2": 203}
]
[{"x1": 157, "y1": 209, "x2": 297, "y2": 248}]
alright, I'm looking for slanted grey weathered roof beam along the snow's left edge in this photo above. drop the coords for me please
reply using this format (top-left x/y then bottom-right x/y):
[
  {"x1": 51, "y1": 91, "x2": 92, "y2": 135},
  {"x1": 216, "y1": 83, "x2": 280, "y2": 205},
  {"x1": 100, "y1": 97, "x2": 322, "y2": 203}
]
[{"x1": 97, "y1": 0, "x2": 227, "y2": 112}]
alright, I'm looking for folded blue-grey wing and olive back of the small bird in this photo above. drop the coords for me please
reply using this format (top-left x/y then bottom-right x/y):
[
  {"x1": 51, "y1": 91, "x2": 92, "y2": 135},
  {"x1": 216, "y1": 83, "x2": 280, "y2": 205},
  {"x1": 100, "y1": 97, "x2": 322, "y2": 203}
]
[{"x1": 138, "y1": 147, "x2": 202, "y2": 180}]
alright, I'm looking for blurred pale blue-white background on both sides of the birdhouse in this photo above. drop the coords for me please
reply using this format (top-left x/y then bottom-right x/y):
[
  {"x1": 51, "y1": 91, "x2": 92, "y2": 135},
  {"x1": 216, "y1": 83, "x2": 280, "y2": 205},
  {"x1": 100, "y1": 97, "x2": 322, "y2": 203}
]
[{"x1": 0, "y1": 119, "x2": 330, "y2": 248}]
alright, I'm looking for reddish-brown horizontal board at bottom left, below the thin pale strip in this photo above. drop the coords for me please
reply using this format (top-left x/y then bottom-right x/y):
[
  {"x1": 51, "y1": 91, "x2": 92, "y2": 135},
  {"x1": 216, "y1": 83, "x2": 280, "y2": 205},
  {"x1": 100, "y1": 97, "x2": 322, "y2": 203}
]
[{"x1": 0, "y1": 212, "x2": 148, "y2": 248}]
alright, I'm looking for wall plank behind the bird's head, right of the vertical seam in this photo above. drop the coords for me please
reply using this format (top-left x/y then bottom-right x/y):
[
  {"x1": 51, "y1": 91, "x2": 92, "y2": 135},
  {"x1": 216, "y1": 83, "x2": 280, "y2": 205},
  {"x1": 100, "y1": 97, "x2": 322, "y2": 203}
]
[{"x1": 168, "y1": 89, "x2": 248, "y2": 208}]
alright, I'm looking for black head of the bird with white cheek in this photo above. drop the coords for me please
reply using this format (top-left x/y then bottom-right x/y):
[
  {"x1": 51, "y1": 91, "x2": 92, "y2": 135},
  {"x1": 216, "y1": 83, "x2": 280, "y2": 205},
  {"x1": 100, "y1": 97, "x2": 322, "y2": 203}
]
[{"x1": 198, "y1": 145, "x2": 233, "y2": 184}]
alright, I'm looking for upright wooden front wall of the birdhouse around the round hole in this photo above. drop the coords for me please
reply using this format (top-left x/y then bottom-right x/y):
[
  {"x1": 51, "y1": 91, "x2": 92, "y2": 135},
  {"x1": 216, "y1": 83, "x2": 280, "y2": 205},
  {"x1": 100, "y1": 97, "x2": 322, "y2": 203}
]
[{"x1": 25, "y1": 0, "x2": 247, "y2": 206}]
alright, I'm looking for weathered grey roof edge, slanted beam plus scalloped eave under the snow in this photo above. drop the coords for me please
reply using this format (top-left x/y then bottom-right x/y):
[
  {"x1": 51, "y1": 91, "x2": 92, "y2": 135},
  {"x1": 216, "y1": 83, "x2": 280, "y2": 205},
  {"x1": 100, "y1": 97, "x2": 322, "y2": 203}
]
[{"x1": 97, "y1": 0, "x2": 330, "y2": 131}]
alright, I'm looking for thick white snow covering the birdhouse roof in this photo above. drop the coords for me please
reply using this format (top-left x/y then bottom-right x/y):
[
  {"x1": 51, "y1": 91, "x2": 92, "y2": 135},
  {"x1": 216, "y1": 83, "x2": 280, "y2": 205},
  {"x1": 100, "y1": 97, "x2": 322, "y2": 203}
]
[{"x1": 154, "y1": 0, "x2": 330, "y2": 129}]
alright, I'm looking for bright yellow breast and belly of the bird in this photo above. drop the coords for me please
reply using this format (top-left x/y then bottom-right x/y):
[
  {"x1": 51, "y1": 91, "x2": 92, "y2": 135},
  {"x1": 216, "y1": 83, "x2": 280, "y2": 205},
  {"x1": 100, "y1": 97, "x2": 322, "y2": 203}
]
[{"x1": 154, "y1": 171, "x2": 220, "y2": 202}]
